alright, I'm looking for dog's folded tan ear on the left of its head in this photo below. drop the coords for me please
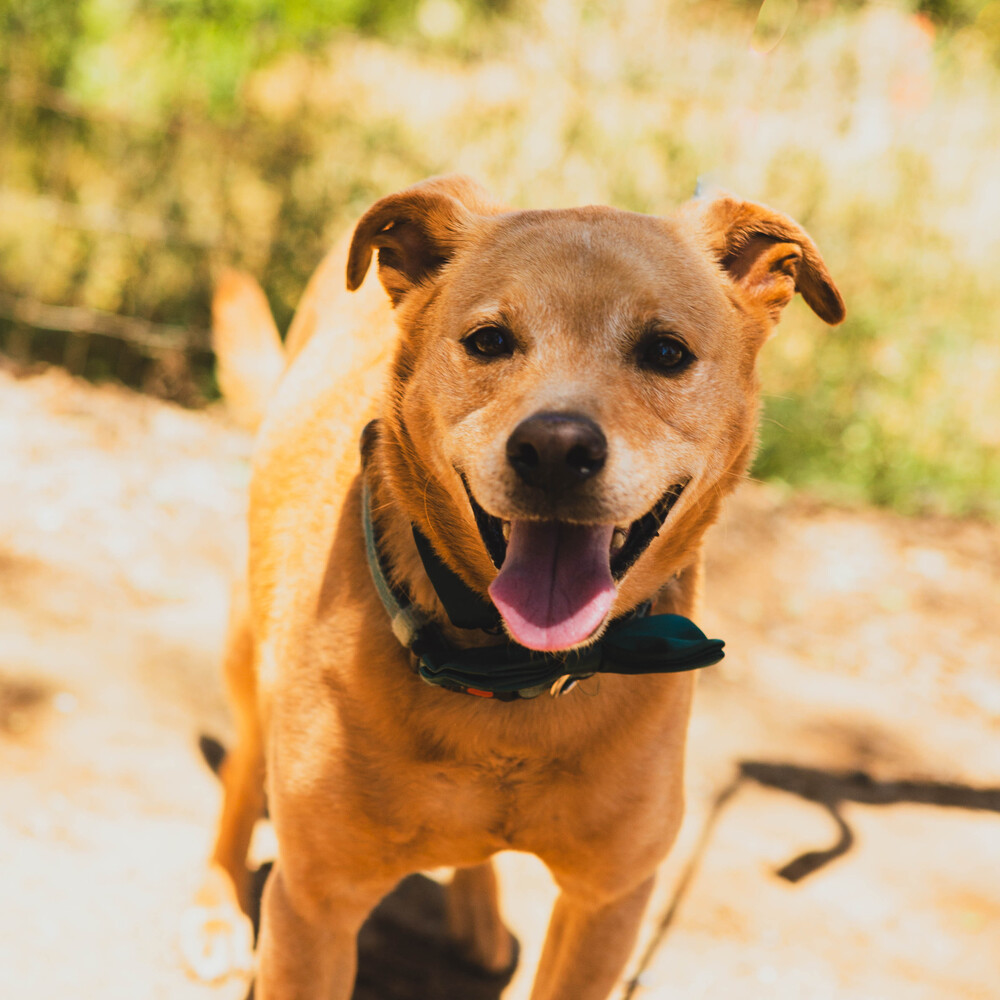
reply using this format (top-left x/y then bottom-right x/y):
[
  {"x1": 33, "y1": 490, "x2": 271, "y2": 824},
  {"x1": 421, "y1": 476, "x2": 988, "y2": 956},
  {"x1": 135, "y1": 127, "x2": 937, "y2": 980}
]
[{"x1": 347, "y1": 174, "x2": 503, "y2": 306}]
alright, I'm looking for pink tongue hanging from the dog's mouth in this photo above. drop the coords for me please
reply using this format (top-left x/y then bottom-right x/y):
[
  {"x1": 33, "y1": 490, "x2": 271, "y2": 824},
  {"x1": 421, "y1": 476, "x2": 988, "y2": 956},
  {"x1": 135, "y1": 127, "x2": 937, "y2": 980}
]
[{"x1": 490, "y1": 521, "x2": 615, "y2": 651}]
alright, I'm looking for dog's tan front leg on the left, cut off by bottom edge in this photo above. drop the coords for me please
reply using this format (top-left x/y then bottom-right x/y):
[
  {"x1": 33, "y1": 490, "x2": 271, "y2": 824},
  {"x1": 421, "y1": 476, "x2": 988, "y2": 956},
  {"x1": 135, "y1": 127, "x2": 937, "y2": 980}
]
[{"x1": 254, "y1": 860, "x2": 382, "y2": 1000}]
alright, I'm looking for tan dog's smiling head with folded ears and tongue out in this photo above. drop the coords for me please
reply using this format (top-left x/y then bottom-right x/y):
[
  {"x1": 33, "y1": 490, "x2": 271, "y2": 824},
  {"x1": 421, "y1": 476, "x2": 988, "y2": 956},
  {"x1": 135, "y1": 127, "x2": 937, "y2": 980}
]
[{"x1": 347, "y1": 177, "x2": 844, "y2": 650}]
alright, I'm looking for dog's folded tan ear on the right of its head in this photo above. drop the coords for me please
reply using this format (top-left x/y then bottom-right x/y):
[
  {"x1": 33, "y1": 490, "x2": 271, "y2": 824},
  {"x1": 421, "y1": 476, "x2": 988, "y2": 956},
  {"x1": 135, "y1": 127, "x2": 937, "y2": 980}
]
[{"x1": 692, "y1": 195, "x2": 844, "y2": 324}]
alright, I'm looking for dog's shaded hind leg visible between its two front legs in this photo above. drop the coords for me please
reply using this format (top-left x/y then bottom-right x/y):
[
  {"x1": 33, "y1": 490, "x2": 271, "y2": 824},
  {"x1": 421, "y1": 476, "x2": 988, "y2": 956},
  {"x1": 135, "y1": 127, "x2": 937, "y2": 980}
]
[{"x1": 447, "y1": 861, "x2": 515, "y2": 972}]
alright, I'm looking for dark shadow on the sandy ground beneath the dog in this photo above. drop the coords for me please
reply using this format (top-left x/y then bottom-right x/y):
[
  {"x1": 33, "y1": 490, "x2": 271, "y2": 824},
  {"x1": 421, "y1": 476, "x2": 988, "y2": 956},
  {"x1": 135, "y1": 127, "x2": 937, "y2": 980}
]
[{"x1": 199, "y1": 736, "x2": 519, "y2": 1000}]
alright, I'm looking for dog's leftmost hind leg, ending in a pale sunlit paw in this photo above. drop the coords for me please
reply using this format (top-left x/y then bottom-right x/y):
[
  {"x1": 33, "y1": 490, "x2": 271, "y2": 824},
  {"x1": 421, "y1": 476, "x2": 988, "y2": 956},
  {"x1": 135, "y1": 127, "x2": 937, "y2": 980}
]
[{"x1": 181, "y1": 584, "x2": 264, "y2": 981}]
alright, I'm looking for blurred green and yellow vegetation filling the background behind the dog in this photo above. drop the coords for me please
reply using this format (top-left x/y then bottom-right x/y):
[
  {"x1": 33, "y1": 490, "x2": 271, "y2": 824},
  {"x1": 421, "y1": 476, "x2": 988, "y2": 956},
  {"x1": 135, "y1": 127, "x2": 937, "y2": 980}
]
[{"x1": 0, "y1": 0, "x2": 1000, "y2": 517}]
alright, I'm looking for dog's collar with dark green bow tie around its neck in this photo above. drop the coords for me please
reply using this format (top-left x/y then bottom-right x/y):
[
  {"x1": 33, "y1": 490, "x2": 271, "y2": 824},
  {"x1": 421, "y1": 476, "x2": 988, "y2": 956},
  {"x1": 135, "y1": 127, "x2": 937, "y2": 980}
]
[{"x1": 361, "y1": 476, "x2": 725, "y2": 701}]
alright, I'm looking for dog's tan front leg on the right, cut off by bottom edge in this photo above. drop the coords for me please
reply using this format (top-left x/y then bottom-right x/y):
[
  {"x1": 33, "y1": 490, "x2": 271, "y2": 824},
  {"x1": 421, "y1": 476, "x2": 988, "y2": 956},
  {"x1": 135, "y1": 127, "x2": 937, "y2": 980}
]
[{"x1": 531, "y1": 876, "x2": 653, "y2": 1000}]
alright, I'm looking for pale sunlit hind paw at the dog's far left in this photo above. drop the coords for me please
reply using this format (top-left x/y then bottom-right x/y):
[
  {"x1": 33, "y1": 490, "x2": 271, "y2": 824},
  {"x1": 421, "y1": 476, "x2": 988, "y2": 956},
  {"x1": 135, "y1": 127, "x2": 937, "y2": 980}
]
[{"x1": 180, "y1": 871, "x2": 254, "y2": 983}]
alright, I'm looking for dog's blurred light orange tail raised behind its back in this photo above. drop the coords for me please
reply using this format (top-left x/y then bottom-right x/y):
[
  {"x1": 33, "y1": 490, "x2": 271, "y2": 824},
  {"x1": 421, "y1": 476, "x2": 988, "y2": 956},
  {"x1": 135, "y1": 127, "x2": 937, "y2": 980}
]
[{"x1": 212, "y1": 270, "x2": 285, "y2": 430}]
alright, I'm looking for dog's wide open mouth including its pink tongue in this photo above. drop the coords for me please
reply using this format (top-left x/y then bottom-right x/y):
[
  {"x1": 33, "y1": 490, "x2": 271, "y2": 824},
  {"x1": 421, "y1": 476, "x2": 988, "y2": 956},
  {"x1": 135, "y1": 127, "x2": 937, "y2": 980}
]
[{"x1": 463, "y1": 480, "x2": 688, "y2": 651}]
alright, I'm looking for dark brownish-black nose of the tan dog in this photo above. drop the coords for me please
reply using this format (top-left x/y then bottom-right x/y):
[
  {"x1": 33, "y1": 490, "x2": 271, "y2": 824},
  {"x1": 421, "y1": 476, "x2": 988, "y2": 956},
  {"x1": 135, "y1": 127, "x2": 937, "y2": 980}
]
[{"x1": 507, "y1": 413, "x2": 608, "y2": 494}]
